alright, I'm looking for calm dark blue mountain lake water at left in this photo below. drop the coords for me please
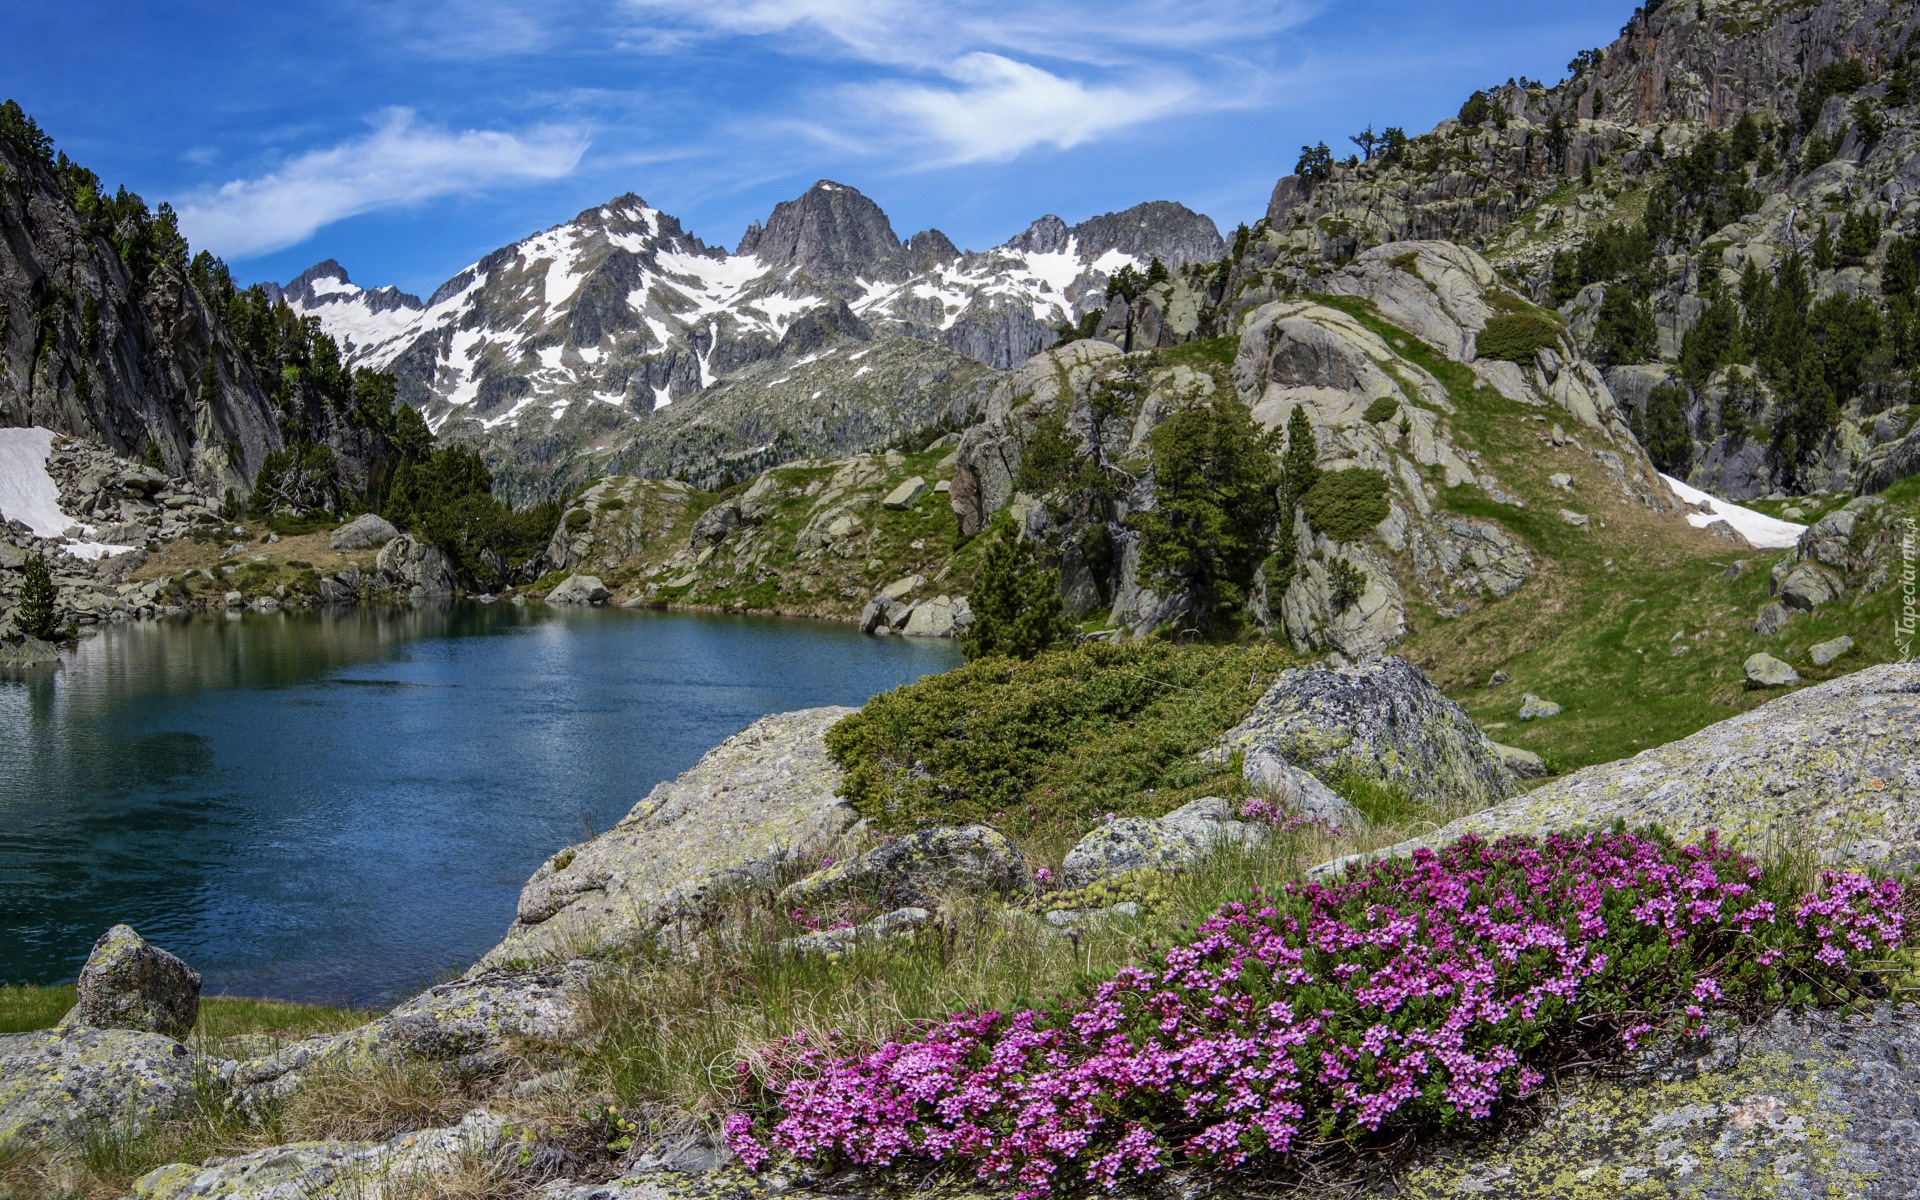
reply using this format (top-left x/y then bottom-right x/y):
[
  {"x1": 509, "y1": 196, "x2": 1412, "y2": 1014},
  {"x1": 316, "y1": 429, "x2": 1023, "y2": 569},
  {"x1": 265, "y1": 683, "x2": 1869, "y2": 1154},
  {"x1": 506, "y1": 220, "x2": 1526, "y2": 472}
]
[{"x1": 0, "y1": 605, "x2": 958, "y2": 1004}]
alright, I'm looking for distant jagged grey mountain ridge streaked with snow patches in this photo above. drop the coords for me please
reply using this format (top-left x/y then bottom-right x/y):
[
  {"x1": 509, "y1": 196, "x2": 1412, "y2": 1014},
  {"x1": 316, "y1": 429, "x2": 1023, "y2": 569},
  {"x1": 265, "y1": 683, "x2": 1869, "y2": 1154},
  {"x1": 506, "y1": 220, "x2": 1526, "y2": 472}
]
[{"x1": 275, "y1": 180, "x2": 1223, "y2": 495}]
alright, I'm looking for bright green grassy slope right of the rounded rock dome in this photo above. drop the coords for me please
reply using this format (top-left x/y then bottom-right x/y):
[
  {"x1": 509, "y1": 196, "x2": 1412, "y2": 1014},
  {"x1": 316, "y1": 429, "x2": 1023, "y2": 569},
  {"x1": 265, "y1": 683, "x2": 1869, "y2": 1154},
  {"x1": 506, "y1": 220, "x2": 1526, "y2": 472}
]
[{"x1": 1323, "y1": 298, "x2": 1920, "y2": 770}]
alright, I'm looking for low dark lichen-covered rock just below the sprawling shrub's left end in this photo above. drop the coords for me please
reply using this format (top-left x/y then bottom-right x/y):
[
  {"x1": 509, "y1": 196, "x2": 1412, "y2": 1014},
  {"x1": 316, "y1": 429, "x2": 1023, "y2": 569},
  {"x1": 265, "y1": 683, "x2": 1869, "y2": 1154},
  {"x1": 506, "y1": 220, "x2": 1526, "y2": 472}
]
[{"x1": 780, "y1": 826, "x2": 1027, "y2": 908}]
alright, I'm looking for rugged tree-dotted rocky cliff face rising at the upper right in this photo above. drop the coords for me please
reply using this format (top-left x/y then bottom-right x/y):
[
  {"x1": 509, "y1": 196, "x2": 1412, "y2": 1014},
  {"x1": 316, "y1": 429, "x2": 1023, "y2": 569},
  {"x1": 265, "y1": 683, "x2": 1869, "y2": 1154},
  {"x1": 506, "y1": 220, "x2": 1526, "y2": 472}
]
[{"x1": 1206, "y1": 0, "x2": 1920, "y2": 499}]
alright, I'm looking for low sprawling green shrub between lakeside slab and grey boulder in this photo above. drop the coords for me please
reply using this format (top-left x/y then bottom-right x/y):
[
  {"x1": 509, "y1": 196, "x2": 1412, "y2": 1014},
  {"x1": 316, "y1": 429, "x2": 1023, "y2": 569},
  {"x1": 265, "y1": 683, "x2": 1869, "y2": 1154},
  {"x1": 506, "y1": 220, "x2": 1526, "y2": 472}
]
[{"x1": 828, "y1": 641, "x2": 1290, "y2": 833}]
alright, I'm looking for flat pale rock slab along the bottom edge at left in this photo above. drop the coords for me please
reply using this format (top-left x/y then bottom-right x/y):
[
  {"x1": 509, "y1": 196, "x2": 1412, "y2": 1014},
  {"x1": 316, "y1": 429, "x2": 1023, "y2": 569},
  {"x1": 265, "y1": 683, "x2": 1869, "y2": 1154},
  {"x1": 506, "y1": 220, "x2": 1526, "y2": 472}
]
[{"x1": 132, "y1": 1110, "x2": 511, "y2": 1200}]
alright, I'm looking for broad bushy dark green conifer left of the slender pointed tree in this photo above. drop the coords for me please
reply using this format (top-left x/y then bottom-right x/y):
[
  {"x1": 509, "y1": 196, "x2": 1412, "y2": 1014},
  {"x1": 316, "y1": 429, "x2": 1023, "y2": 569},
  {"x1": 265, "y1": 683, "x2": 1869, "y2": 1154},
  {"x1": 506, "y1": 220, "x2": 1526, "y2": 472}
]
[{"x1": 1127, "y1": 394, "x2": 1281, "y2": 634}]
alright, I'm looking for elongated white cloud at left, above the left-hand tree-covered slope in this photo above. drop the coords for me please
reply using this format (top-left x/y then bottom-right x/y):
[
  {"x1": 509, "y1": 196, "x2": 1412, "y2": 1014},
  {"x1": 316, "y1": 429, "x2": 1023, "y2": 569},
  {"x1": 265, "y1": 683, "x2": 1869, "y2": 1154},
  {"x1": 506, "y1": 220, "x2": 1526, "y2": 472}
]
[{"x1": 180, "y1": 108, "x2": 588, "y2": 259}]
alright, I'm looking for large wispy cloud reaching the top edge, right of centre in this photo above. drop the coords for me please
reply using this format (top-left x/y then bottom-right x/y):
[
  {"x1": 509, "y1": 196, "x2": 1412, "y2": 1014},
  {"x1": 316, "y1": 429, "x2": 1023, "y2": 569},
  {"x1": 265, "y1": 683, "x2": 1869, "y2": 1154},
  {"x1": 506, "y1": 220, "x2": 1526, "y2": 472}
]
[{"x1": 624, "y1": 0, "x2": 1317, "y2": 167}]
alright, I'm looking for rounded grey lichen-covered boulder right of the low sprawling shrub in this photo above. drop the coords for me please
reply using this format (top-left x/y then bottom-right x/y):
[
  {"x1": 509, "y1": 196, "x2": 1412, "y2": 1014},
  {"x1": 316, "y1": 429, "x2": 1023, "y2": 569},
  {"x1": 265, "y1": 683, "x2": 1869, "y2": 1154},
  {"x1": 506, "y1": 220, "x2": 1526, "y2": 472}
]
[{"x1": 1212, "y1": 657, "x2": 1515, "y2": 806}]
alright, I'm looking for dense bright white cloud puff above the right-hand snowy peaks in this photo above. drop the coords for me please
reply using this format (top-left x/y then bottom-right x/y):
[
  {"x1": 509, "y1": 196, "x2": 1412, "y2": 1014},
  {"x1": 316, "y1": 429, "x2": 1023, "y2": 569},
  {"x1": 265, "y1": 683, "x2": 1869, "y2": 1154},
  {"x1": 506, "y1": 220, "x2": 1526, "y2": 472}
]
[{"x1": 847, "y1": 52, "x2": 1200, "y2": 165}]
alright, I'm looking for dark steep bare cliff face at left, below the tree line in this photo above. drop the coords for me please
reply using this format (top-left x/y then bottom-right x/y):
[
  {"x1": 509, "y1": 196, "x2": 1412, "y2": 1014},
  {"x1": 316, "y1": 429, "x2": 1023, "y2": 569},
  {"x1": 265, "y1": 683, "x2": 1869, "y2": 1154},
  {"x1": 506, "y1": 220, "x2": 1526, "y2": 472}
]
[{"x1": 0, "y1": 130, "x2": 280, "y2": 487}]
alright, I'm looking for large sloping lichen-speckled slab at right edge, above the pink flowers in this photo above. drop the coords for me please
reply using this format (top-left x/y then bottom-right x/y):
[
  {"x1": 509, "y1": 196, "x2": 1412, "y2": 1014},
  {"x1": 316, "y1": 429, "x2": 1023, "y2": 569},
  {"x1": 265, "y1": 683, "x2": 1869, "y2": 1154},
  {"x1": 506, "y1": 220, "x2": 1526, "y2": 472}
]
[{"x1": 1394, "y1": 662, "x2": 1920, "y2": 868}]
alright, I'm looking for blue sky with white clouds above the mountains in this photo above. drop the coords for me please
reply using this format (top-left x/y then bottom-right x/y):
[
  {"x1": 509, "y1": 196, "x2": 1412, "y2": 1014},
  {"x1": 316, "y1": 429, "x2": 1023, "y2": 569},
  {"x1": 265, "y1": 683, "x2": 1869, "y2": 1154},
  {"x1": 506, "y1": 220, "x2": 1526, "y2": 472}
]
[{"x1": 11, "y1": 0, "x2": 1632, "y2": 296}]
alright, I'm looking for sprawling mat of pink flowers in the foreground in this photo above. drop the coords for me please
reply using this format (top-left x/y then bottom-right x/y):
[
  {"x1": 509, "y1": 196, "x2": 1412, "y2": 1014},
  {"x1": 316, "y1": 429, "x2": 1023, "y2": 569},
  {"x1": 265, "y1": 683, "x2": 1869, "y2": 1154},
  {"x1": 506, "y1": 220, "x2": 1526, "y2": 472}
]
[{"x1": 726, "y1": 831, "x2": 1910, "y2": 1196}]
